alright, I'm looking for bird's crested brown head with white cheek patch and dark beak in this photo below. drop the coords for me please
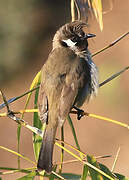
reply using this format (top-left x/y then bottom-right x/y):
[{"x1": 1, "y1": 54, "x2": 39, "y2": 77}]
[{"x1": 53, "y1": 21, "x2": 95, "y2": 51}]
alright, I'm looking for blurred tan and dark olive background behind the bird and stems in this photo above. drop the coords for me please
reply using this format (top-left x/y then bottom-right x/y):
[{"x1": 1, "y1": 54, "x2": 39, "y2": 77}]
[{"x1": 0, "y1": 0, "x2": 129, "y2": 180}]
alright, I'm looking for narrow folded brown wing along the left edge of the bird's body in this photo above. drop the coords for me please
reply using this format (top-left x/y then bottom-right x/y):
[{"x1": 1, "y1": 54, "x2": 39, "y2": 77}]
[{"x1": 38, "y1": 83, "x2": 48, "y2": 123}]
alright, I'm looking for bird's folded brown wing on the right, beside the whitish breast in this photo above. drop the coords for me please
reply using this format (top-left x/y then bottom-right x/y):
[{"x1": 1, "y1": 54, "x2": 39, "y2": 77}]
[{"x1": 59, "y1": 57, "x2": 90, "y2": 125}]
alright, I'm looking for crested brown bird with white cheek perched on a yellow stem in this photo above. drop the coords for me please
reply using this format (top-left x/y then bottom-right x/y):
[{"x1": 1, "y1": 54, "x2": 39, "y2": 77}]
[{"x1": 37, "y1": 20, "x2": 99, "y2": 173}]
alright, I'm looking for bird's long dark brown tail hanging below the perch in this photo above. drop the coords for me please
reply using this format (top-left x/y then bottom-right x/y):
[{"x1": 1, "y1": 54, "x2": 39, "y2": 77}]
[{"x1": 37, "y1": 127, "x2": 56, "y2": 173}]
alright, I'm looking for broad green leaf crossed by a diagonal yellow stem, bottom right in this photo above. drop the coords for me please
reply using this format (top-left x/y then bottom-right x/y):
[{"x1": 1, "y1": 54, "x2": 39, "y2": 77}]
[{"x1": 87, "y1": 155, "x2": 103, "y2": 180}]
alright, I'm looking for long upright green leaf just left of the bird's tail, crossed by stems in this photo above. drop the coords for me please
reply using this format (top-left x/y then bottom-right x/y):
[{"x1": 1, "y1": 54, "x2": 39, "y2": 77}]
[{"x1": 33, "y1": 83, "x2": 42, "y2": 161}]
